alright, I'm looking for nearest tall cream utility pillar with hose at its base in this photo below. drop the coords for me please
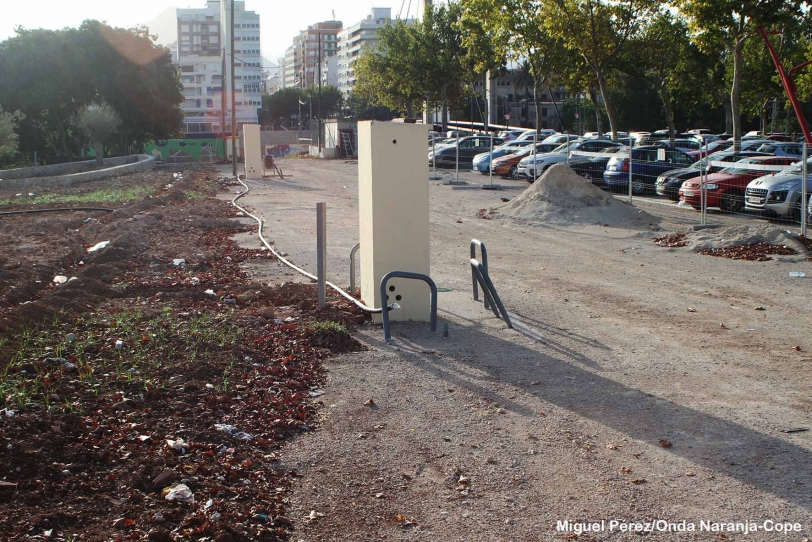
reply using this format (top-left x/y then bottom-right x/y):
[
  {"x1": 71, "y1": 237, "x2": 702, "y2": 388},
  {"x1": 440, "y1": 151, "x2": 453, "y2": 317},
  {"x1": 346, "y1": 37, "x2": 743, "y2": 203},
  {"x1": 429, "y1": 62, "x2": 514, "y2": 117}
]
[{"x1": 358, "y1": 121, "x2": 431, "y2": 323}]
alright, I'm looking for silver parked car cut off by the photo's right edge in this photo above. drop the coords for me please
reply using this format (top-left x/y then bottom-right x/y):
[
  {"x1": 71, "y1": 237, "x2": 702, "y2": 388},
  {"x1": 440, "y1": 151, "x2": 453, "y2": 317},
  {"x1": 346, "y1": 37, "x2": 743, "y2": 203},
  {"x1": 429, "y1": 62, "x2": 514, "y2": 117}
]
[{"x1": 744, "y1": 158, "x2": 812, "y2": 221}]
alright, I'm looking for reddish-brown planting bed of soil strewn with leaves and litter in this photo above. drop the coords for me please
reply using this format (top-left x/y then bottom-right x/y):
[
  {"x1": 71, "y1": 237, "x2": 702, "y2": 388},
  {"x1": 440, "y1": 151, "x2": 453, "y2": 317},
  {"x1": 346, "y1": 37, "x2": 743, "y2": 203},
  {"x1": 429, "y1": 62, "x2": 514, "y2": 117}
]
[{"x1": 0, "y1": 168, "x2": 364, "y2": 542}]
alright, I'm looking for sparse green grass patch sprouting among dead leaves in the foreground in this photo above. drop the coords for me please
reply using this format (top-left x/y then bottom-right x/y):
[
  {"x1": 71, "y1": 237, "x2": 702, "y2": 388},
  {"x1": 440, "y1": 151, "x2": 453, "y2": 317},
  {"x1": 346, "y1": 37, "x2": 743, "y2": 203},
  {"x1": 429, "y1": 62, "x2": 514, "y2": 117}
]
[{"x1": 0, "y1": 307, "x2": 245, "y2": 410}]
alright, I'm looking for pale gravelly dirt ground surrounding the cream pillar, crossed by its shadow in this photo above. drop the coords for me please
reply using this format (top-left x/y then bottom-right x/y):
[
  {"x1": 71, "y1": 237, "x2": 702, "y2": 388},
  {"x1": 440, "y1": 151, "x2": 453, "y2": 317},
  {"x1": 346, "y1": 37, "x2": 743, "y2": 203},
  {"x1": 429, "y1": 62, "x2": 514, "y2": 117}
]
[{"x1": 232, "y1": 159, "x2": 812, "y2": 542}]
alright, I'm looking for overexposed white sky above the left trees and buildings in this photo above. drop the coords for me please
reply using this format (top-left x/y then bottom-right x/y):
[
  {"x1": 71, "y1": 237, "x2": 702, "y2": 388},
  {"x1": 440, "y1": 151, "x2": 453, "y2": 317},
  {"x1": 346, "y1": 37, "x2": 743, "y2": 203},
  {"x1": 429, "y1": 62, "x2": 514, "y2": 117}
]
[{"x1": 0, "y1": 0, "x2": 424, "y2": 62}]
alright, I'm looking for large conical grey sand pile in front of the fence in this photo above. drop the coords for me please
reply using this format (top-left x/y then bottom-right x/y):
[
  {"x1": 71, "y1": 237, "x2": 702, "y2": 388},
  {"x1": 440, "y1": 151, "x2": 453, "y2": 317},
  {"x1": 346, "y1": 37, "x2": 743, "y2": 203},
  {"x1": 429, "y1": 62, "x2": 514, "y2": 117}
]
[{"x1": 497, "y1": 164, "x2": 660, "y2": 228}]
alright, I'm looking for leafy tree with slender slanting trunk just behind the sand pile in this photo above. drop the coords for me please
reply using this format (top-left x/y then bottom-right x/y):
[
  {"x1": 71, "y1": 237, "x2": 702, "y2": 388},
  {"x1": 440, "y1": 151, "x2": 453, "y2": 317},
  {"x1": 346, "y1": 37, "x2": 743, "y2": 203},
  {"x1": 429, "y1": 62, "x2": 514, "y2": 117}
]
[{"x1": 542, "y1": 0, "x2": 653, "y2": 140}]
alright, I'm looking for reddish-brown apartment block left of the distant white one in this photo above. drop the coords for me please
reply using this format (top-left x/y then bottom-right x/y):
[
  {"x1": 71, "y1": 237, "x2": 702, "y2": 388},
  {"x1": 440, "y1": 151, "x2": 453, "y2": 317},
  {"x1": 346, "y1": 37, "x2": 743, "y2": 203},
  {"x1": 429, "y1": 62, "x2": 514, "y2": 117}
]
[{"x1": 282, "y1": 21, "x2": 343, "y2": 88}]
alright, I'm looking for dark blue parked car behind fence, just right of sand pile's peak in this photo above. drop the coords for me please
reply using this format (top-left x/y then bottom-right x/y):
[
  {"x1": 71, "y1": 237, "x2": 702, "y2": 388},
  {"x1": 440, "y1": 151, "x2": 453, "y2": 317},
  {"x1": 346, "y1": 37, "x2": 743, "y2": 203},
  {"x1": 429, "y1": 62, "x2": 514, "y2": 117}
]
[{"x1": 603, "y1": 145, "x2": 693, "y2": 194}]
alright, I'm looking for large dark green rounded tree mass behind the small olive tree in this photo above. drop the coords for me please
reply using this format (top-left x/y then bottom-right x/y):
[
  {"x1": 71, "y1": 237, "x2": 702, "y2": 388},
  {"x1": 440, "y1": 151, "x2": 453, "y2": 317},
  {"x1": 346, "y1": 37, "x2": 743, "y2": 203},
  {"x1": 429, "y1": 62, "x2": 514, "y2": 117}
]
[{"x1": 0, "y1": 21, "x2": 183, "y2": 162}]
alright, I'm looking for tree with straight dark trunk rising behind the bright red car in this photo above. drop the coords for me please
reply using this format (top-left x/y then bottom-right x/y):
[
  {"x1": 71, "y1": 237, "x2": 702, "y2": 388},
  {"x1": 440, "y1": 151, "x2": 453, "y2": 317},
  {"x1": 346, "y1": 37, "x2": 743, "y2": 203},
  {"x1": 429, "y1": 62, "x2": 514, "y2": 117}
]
[{"x1": 677, "y1": 0, "x2": 800, "y2": 150}]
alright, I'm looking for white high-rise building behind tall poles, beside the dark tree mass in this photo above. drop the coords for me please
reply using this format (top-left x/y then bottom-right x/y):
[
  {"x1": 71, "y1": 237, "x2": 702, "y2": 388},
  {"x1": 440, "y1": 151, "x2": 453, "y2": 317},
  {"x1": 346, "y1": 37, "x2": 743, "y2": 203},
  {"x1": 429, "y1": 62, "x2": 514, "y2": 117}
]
[{"x1": 177, "y1": 0, "x2": 263, "y2": 135}]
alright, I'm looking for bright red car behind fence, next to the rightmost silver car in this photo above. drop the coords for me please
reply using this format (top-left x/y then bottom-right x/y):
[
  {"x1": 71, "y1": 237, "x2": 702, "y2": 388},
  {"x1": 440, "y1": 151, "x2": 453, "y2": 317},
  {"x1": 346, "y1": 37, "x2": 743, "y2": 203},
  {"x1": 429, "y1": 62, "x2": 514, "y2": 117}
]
[{"x1": 679, "y1": 156, "x2": 797, "y2": 213}]
